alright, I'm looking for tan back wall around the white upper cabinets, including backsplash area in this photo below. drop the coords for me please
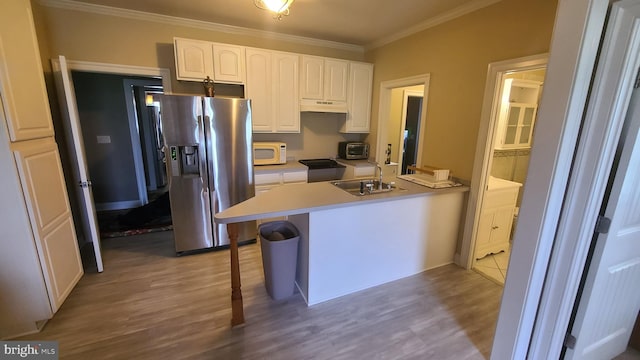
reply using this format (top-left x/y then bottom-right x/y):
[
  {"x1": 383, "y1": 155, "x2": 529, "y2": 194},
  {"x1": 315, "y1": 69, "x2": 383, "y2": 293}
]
[{"x1": 31, "y1": 0, "x2": 364, "y2": 178}]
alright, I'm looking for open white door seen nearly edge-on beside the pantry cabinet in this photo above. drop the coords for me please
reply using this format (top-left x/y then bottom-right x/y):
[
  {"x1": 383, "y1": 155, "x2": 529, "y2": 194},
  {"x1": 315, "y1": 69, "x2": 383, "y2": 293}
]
[{"x1": 51, "y1": 56, "x2": 103, "y2": 272}]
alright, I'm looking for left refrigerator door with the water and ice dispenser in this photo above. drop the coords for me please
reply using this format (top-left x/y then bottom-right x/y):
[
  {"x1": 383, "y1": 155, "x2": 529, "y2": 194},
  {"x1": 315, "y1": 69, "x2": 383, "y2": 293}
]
[{"x1": 161, "y1": 95, "x2": 214, "y2": 252}]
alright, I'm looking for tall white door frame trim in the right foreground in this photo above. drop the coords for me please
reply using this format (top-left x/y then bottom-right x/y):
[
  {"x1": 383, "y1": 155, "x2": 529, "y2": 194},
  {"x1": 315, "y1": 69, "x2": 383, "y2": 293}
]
[{"x1": 491, "y1": 0, "x2": 608, "y2": 359}]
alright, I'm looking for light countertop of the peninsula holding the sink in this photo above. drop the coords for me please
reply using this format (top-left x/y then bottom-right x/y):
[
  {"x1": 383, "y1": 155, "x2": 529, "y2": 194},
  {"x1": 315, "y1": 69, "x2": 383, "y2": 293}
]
[{"x1": 215, "y1": 178, "x2": 469, "y2": 224}]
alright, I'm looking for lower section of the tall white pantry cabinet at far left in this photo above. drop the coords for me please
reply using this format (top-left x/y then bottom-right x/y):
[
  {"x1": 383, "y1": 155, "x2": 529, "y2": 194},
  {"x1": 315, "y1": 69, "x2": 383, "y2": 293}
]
[{"x1": 0, "y1": 136, "x2": 84, "y2": 339}]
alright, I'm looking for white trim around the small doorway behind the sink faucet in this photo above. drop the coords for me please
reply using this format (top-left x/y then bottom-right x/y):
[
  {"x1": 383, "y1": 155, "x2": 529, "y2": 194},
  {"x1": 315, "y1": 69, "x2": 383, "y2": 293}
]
[{"x1": 376, "y1": 74, "x2": 431, "y2": 164}]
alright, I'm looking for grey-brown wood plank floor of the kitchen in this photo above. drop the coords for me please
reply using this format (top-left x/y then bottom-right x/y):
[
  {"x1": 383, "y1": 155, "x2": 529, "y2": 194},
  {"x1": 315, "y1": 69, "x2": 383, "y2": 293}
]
[{"x1": 20, "y1": 232, "x2": 502, "y2": 360}]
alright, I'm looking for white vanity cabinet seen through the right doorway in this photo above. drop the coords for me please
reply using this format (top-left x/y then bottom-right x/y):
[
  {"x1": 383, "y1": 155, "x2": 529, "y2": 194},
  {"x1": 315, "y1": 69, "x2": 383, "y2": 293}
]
[{"x1": 475, "y1": 180, "x2": 521, "y2": 259}]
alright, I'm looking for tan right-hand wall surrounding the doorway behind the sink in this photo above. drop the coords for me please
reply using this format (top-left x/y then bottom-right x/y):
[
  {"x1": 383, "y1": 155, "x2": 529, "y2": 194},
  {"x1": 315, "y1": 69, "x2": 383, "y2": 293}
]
[{"x1": 366, "y1": 0, "x2": 556, "y2": 180}]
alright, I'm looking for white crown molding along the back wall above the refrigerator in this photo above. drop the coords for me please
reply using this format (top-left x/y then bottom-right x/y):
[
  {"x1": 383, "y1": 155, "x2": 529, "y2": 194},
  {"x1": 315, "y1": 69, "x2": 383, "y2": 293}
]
[{"x1": 38, "y1": 0, "x2": 364, "y2": 53}]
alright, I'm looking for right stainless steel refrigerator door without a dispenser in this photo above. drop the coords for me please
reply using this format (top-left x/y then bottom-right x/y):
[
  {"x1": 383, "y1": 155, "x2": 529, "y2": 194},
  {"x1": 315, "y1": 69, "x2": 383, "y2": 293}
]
[{"x1": 204, "y1": 97, "x2": 256, "y2": 246}]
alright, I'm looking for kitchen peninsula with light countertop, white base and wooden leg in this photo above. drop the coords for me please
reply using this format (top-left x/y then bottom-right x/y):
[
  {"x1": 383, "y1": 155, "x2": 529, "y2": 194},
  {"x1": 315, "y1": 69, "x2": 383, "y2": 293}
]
[{"x1": 215, "y1": 178, "x2": 468, "y2": 325}]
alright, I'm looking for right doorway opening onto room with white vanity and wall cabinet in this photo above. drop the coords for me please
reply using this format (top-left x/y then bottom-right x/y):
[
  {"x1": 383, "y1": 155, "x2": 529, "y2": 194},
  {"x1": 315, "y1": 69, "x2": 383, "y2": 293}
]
[{"x1": 473, "y1": 68, "x2": 546, "y2": 285}]
